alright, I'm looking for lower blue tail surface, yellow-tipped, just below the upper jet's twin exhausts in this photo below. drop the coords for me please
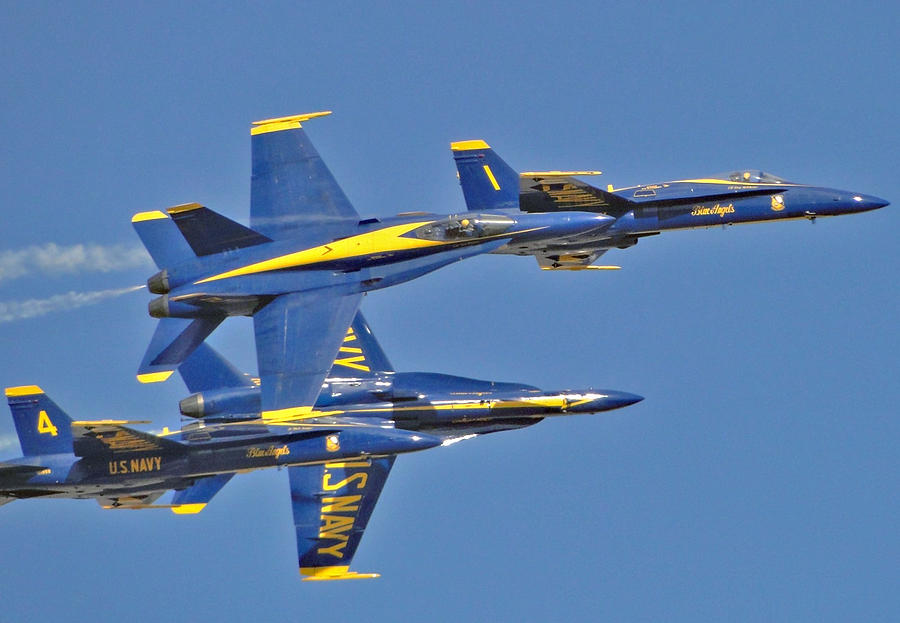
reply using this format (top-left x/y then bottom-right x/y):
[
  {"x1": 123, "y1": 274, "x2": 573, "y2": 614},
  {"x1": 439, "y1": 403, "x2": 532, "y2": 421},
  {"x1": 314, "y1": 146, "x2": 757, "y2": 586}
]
[{"x1": 137, "y1": 316, "x2": 225, "y2": 383}]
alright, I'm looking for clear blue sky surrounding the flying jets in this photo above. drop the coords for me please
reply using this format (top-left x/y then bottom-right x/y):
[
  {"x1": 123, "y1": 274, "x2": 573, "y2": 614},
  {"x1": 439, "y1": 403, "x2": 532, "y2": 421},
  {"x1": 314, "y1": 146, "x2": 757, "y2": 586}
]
[{"x1": 0, "y1": 1, "x2": 900, "y2": 622}]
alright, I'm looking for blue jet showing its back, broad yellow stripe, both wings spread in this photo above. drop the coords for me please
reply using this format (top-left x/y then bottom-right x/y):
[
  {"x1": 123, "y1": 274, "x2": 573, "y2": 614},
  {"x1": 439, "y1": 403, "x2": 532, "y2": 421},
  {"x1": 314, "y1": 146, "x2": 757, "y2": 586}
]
[{"x1": 132, "y1": 112, "x2": 615, "y2": 424}]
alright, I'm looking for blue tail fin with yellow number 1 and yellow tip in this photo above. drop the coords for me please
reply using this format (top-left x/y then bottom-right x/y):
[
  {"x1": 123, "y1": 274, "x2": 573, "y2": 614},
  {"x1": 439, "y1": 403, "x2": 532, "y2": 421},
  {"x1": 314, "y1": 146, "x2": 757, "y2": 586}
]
[{"x1": 450, "y1": 140, "x2": 519, "y2": 212}]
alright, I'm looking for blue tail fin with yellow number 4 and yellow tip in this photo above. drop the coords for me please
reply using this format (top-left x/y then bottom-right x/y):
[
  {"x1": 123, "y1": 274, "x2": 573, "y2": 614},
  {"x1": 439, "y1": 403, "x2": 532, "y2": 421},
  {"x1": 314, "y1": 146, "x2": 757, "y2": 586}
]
[{"x1": 6, "y1": 385, "x2": 72, "y2": 456}]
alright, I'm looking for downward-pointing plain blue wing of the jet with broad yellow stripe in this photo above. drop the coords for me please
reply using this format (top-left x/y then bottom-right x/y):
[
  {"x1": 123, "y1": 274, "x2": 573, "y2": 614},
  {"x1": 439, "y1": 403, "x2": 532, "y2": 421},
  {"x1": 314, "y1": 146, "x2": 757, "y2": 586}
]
[{"x1": 253, "y1": 291, "x2": 362, "y2": 420}]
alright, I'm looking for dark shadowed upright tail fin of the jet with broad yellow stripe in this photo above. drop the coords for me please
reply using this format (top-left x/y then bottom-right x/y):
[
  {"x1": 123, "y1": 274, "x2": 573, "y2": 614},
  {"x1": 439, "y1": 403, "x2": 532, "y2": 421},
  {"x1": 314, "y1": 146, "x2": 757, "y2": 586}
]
[{"x1": 167, "y1": 203, "x2": 272, "y2": 257}]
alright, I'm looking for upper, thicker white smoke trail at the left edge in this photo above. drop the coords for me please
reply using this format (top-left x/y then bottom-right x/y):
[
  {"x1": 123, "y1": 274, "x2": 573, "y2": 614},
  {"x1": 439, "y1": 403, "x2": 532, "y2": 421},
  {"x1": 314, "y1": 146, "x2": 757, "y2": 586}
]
[{"x1": 0, "y1": 242, "x2": 150, "y2": 281}]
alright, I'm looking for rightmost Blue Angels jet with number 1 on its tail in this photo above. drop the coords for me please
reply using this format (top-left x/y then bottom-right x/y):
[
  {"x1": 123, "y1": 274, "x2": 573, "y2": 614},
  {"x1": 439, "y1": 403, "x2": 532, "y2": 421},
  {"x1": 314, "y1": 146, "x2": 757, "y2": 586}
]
[{"x1": 450, "y1": 140, "x2": 888, "y2": 270}]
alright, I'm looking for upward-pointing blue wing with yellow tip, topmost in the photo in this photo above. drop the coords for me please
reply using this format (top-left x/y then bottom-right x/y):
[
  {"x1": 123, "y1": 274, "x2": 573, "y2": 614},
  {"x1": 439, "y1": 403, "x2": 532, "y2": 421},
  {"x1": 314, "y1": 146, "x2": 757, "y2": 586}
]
[{"x1": 250, "y1": 111, "x2": 359, "y2": 239}]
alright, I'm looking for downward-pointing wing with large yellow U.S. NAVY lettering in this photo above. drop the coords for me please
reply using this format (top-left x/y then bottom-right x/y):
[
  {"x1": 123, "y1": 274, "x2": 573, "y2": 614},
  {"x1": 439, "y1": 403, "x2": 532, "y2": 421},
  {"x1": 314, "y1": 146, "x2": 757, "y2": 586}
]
[{"x1": 288, "y1": 456, "x2": 395, "y2": 580}]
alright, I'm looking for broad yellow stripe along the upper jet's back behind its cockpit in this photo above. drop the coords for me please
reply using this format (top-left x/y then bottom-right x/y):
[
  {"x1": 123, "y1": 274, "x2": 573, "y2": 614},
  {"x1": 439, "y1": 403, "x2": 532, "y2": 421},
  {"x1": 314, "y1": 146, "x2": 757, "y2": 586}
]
[{"x1": 196, "y1": 221, "x2": 442, "y2": 284}]
